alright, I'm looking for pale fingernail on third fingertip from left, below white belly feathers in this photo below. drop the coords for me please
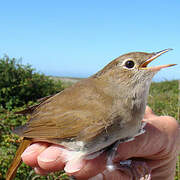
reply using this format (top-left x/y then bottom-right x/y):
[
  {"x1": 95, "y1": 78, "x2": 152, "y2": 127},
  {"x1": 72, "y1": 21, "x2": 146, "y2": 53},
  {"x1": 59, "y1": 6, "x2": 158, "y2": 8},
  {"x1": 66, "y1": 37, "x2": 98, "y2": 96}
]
[{"x1": 64, "y1": 159, "x2": 84, "y2": 173}]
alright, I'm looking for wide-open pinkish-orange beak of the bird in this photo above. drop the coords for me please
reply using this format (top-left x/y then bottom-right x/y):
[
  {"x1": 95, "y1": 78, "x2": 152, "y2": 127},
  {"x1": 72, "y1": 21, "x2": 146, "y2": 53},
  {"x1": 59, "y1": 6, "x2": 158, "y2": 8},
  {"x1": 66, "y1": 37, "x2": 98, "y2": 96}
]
[{"x1": 139, "y1": 48, "x2": 176, "y2": 71}]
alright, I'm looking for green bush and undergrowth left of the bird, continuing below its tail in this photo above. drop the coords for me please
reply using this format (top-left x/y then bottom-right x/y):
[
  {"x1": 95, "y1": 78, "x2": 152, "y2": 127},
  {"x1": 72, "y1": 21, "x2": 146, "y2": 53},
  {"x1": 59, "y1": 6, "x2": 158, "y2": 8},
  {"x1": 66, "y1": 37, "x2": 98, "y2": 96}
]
[{"x1": 0, "y1": 56, "x2": 67, "y2": 180}]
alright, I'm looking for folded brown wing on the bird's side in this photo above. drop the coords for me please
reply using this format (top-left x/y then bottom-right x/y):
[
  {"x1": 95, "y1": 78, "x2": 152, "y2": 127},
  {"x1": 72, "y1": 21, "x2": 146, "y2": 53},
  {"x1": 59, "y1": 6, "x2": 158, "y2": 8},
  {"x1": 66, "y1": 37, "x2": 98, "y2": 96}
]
[{"x1": 16, "y1": 79, "x2": 112, "y2": 143}]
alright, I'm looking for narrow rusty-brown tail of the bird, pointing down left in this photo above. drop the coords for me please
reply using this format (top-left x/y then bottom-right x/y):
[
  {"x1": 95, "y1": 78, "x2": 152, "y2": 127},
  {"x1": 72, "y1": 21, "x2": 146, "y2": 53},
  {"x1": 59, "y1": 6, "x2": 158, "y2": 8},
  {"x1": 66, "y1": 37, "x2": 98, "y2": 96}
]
[{"x1": 6, "y1": 138, "x2": 32, "y2": 180}]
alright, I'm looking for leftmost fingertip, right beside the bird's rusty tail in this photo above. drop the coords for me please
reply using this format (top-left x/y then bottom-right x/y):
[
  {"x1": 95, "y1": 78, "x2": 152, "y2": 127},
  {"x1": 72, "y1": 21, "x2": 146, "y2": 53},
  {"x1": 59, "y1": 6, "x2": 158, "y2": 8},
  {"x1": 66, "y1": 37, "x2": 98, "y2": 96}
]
[{"x1": 21, "y1": 142, "x2": 49, "y2": 167}]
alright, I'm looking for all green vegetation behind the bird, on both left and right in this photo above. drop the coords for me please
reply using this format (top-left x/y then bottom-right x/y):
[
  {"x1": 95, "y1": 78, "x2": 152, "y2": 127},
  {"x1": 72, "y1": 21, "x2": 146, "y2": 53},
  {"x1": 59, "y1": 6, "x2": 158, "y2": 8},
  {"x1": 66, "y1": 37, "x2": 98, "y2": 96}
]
[{"x1": 0, "y1": 56, "x2": 180, "y2": 180}]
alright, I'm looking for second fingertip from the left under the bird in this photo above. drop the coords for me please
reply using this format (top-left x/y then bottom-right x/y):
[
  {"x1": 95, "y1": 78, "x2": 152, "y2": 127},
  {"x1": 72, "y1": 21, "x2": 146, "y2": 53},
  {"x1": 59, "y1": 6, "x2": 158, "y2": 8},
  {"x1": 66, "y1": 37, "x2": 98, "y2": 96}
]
[{"x1": 37, "y1": 145, "x2": 71, "y2": 171}]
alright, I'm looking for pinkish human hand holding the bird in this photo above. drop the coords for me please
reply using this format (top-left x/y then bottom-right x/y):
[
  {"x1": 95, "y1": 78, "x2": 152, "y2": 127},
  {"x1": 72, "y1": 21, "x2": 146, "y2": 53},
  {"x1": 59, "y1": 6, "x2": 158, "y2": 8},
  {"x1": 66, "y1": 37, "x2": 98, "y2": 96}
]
[{"x1": 22, "y1": 106, "x2": 180, "y2": 180}]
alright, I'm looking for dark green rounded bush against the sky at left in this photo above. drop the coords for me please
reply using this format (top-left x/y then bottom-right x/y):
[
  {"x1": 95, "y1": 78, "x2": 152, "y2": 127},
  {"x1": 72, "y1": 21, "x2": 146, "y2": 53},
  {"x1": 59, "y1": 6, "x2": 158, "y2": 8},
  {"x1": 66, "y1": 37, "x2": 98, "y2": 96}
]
[{"x1": 0, "y1": 56, "x2": 63, "y2": 109}]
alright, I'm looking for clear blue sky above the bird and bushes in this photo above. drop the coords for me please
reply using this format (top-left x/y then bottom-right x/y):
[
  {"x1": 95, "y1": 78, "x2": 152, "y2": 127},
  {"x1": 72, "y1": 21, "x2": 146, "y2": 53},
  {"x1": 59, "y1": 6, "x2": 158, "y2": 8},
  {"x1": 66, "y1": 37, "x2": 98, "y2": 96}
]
[{"x1": 0, "y1": 0, "x2": 180, "y2": 80}]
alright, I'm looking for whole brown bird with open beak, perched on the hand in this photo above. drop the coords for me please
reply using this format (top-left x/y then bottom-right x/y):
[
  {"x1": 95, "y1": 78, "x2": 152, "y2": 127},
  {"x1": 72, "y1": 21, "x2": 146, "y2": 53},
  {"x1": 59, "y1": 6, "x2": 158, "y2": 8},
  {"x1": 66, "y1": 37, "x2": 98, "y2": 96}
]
[{"x1": 6, "y1": 48, "x2": 175, "y2": 180}]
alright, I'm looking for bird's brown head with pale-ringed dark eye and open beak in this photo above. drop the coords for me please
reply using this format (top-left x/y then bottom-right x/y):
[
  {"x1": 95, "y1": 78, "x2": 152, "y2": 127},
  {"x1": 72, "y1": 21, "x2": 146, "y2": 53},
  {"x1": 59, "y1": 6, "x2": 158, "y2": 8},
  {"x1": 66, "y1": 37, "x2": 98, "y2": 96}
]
[{"x1": 96, "y1": 49, "x2": 176, "y2": 85}]
